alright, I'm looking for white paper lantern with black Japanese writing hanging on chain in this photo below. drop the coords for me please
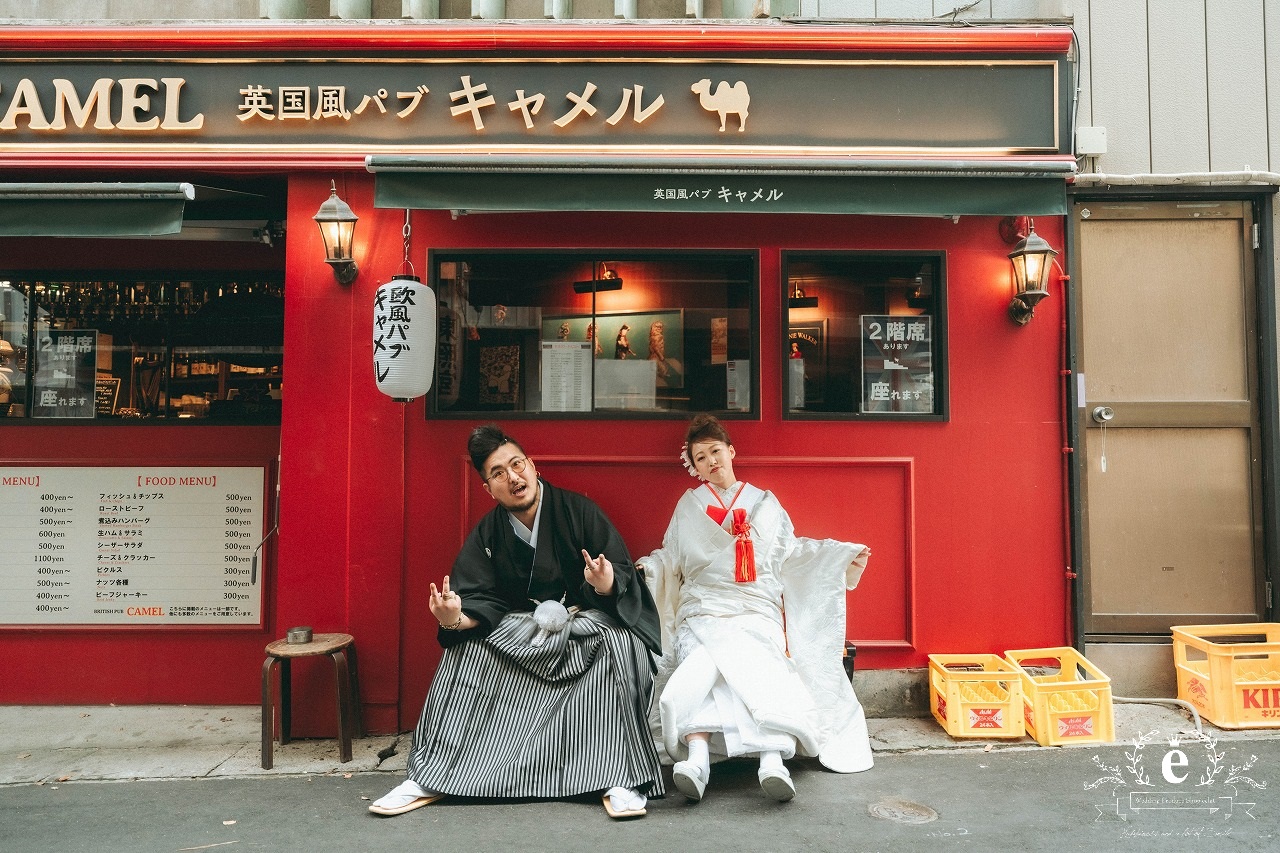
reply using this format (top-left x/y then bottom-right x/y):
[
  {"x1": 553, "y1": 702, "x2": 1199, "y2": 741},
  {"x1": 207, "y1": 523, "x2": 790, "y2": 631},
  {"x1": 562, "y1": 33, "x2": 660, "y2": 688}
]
[{"x1": 374, "y1": 275, "x2": 435, "y2": 402}]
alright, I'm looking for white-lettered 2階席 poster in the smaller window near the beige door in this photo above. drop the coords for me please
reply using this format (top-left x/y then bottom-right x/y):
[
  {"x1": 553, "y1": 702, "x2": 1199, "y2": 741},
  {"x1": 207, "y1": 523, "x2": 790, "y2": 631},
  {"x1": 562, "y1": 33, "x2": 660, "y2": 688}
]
[{"x1": 860, "y1": 314, "x2": 934, "y2": 415}]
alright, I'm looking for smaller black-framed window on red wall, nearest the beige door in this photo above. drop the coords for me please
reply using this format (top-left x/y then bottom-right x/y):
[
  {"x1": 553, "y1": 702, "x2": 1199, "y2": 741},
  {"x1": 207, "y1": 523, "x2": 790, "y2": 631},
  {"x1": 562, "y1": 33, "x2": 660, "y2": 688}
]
[{"x1": 782, "y1": 252, "x2": 947, "y2": 420}]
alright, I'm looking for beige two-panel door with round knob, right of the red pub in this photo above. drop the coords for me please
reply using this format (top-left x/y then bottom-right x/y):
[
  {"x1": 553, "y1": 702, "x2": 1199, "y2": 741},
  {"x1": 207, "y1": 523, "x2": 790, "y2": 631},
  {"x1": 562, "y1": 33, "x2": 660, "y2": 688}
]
[{"x1": 1071, "y1": 201, "x2": 1265, "y2": 639}]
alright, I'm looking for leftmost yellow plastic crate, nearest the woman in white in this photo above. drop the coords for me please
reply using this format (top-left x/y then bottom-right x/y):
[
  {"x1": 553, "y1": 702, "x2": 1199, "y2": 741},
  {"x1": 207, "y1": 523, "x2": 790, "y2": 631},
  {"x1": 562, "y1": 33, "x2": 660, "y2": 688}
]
[{"x1": 929, "y1": 654, "x2": 1024, "y2": 738}]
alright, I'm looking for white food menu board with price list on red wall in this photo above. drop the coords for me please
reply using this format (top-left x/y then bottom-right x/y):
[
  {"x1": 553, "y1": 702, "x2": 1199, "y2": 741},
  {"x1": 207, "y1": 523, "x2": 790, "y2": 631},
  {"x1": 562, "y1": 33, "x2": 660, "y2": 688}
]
[{"x1": 0, "y1": 466, "x2": 266, "y2": 628}]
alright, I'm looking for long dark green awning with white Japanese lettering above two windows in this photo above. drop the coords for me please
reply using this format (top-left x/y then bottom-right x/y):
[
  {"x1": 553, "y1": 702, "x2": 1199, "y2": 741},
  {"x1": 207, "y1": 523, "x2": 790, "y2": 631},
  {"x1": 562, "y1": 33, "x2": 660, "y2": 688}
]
[{"x1": 366, "y1": 155, "x2": 1074, "y2": 216}]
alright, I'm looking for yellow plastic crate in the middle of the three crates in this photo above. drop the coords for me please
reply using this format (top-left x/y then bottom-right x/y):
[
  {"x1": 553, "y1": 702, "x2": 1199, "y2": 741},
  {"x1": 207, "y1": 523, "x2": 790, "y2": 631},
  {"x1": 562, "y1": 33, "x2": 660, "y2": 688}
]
[{"x1": 1005, "y1": 648, "x2": 1116, "y2": 747}]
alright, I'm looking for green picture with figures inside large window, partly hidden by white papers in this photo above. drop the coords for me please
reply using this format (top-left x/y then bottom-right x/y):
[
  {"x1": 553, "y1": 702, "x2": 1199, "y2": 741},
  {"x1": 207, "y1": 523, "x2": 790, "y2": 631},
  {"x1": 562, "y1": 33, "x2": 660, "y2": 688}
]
[{"x1": 541, "y1": 309, "x2": 685, "y2": 389}]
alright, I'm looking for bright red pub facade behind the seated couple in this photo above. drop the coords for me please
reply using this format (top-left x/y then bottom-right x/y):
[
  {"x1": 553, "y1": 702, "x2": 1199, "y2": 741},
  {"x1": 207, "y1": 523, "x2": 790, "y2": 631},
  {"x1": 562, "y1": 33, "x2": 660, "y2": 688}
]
[{"x1": 0, "y1": 26, "x2": 1074, "y2": 731}]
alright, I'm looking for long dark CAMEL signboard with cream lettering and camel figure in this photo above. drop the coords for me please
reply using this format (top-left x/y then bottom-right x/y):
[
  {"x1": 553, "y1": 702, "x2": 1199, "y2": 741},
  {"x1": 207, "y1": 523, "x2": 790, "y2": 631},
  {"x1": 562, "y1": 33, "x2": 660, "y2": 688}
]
[{"x1": 0, "y1": 55, "x2": 1069, "y2": 153}]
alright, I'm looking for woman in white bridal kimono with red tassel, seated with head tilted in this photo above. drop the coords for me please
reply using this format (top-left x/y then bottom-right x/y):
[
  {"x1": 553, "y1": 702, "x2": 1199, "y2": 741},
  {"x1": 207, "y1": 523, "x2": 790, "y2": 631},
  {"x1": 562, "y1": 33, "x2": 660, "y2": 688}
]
[{"x1": 636, "y1": 415, "x2": 872, "y2": 800}]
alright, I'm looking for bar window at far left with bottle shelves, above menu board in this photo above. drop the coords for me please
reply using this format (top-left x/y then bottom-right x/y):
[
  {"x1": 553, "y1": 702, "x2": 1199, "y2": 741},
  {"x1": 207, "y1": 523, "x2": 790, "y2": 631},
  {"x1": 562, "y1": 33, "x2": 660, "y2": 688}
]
[{"x1": 0, "y1": 273, "x2": 284, "y2": 423}]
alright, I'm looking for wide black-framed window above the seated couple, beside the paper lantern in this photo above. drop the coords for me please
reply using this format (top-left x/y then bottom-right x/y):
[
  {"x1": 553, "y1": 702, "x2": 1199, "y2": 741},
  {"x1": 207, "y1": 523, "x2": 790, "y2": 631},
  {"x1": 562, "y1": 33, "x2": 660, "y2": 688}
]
[{"x1": 429, "y1": 251, "x2": 759, "y2": 416}]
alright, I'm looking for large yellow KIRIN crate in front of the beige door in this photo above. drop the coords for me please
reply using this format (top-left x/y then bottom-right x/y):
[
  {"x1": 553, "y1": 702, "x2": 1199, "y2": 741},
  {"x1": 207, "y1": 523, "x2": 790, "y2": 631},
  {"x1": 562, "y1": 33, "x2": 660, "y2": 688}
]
[{"x1": 1172, "y1": 622, "x2": 1280, "y2": 729}]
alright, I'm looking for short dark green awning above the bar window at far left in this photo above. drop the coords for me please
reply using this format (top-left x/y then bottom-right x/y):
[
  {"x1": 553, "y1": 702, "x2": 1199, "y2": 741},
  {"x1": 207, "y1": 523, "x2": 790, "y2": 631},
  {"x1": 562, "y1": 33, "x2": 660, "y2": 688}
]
[{"x1": 0, "y1": 183, "x2": 196, "y2": 237}]
